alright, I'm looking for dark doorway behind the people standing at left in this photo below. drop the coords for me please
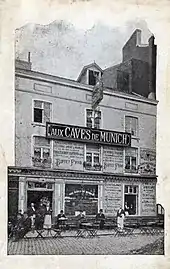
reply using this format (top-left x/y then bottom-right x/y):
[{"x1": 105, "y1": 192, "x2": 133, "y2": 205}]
[{"x1": 27, "y1": 190, "x2": 53, "y2": 209}]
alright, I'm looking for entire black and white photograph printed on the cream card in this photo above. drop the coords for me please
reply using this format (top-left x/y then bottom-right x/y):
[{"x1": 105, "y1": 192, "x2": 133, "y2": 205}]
[{"x1": 7, "y1": 8, "x2": 165, "y2": 255}]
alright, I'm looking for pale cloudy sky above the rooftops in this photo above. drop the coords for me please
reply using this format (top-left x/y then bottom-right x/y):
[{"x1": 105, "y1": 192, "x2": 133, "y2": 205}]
[{"x1": 15, "y1": 20, "x2": 152, "y2": 79}]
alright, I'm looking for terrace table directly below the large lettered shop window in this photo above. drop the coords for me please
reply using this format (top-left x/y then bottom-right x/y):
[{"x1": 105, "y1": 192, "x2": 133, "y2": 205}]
[{"x1": 76, "y1": 223, "x2": 97, "y2": 237}]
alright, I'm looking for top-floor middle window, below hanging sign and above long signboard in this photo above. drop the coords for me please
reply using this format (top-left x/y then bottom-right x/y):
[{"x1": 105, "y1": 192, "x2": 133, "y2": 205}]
[{"x1": 86, "y1": 109, "x2": 101, "y2": 129}]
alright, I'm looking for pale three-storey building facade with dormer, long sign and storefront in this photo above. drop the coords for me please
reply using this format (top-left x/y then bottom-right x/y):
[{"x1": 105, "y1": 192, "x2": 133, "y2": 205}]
[{"x1": 8, "y1": 30, "x2": 157, "y2": 216}]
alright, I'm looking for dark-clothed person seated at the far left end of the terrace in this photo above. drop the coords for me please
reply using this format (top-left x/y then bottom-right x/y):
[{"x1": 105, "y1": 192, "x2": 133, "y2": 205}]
[{"x1": 15, "y1": 212, "x2": 31, "y2": 240}]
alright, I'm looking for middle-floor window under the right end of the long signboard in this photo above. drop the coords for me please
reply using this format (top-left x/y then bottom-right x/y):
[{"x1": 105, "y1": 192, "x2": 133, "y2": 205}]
[{"x1": 125, "y1": 148, "x2": 138, "y2": 172}]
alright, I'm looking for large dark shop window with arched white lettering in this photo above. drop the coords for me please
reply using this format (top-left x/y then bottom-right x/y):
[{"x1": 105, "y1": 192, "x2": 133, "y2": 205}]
[{"x1": 65, "y1": 184, "x2": 98, "y2": 215}]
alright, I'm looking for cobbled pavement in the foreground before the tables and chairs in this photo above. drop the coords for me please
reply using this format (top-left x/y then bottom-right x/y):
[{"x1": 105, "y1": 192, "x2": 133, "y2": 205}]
[{"x1": 8, "y1": 231, "x2": 163, "y2": 255}]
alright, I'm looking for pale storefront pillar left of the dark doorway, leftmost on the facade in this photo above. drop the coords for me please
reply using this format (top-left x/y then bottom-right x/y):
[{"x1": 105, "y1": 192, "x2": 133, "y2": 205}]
[{"x1": 18, "y1": 177, "x2": 26, "y2": 213}]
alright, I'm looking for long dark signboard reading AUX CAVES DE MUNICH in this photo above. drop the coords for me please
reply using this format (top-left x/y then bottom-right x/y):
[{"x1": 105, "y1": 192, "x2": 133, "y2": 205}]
[{"x1": 46, "y1": 122, "x2": 131, "y2": 147}]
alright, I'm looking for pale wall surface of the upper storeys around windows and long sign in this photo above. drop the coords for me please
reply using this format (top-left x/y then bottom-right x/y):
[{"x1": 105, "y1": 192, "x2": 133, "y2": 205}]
[{"x1": 15, "y1": 71, "x2": 156, "y2": 173}]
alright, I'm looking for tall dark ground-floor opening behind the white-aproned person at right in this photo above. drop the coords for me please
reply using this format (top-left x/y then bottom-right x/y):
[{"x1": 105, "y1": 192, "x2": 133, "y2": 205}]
[{"x1": 124, "y1": 185, "x2": 139, "y2": 215}]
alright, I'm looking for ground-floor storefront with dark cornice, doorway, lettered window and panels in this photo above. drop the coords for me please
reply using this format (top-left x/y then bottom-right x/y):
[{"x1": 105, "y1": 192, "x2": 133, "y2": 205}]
[{"x1": 8, "y1": 167, "x2": 156, "y2": 216}]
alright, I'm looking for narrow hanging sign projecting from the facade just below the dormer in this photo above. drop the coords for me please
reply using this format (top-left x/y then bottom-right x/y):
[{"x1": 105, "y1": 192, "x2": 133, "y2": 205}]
[{"x1": 92, "y1": 80, "x2": 103, "y2": 110}]
